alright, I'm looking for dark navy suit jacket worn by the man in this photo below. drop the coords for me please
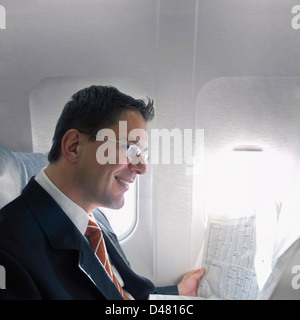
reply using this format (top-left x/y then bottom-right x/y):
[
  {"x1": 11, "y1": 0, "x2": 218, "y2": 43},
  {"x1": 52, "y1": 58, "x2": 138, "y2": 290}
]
[{"x1": 0, "y1": 178, "x2": 177, "y2": 300}]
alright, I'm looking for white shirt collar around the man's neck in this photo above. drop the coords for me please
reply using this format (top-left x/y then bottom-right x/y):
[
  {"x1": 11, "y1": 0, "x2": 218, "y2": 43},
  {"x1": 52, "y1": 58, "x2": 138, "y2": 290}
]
[{"x1": 35, "y1": 168, "x2": 89, "y2": 235}]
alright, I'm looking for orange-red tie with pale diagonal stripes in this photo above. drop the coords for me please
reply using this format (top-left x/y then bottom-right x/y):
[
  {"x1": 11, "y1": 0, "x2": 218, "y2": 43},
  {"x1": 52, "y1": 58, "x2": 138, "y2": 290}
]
[{"x1": 85, "y1": 214, "x2": 130, "y2": 300}]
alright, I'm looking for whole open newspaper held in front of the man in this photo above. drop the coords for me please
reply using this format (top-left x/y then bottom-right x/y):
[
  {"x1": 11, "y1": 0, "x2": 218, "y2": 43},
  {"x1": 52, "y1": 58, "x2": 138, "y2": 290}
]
[{"x1": 150, "y1": 196, "x2": 300, "y2": 300}]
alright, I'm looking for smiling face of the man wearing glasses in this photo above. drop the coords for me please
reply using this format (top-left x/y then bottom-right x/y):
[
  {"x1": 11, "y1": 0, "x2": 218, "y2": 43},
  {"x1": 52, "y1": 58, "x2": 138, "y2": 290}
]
[{"x1": 76, "y1": 110, "x2": 147, "y2": 210}]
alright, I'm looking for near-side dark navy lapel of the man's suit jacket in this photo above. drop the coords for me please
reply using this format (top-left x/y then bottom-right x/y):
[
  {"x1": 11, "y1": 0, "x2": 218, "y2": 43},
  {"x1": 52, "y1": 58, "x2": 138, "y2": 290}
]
[{"x1": 22, "y1": 178, "x2": 123, "y2": 299}]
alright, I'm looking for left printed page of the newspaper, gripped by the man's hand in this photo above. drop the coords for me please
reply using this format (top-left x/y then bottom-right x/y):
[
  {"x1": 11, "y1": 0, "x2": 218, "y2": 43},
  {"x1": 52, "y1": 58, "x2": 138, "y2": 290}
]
[{"x1": 197, "y1": 216, "x2": 259, "y2": 300}]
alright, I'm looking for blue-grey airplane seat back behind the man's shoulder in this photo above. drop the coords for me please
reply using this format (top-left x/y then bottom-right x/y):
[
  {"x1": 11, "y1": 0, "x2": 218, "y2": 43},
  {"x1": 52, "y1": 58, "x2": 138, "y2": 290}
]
[{"x1": 0, "y1": 145, "x2": 48, "y2": 209}]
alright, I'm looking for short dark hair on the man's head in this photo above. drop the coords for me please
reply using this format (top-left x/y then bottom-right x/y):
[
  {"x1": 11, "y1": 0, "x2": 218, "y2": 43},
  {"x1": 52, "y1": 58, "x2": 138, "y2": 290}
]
[{"x1": 48, "y1": 85, "x2": 154, "y2": 162}]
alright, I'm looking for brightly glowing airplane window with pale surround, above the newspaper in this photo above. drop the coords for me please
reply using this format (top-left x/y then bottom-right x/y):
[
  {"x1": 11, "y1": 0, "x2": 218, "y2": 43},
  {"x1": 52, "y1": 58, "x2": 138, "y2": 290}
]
[{"x1": 193, "y1": 77, "x2": 300, "y2": 219}]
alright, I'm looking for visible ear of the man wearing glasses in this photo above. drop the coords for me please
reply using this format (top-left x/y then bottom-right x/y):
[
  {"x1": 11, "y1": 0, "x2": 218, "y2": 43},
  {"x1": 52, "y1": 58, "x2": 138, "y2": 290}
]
[{"x1": 61, "y1": 129, "x2": 80, "y2": 163}]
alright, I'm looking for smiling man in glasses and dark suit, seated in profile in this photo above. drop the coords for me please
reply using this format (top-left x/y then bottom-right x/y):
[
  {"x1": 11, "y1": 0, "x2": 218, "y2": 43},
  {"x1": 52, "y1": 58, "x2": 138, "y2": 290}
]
[{"x1": 0, "y1": 86, "x2": 204, "y2": 299}]
